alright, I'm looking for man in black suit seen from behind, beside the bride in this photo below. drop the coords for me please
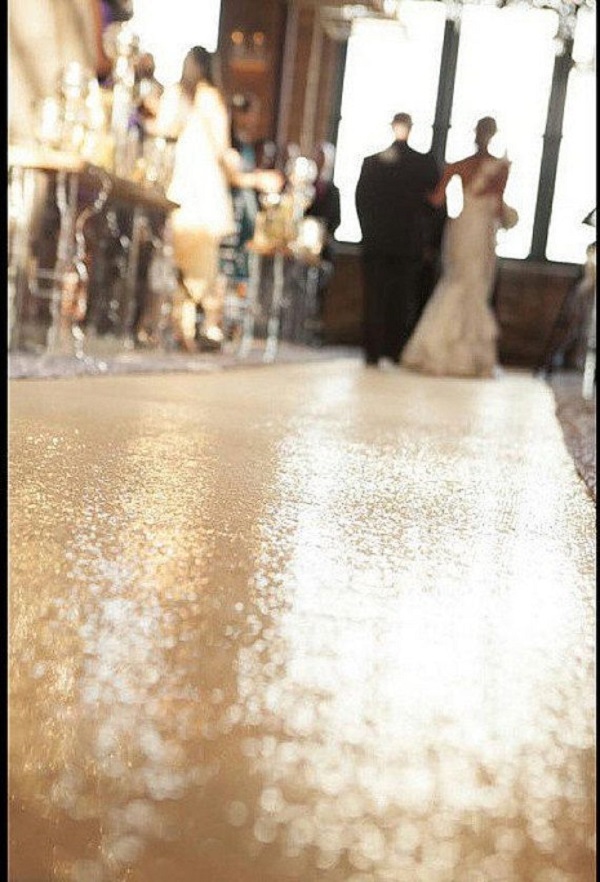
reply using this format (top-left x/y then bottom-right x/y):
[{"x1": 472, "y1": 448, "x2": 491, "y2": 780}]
[{"x1": 356, "y1": 113, "x2": 445, "y2": 365}]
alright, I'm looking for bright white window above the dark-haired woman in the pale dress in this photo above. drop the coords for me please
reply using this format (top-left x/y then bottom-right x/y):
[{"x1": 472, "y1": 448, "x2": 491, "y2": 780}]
[{"x1": 131, "y1": 0, "x2": 221, "y2": 86}]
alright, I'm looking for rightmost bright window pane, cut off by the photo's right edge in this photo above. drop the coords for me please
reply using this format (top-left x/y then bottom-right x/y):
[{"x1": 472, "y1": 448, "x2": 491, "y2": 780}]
[{"x1": 546, "y1": 9, "x2": 596, "y2": 264}]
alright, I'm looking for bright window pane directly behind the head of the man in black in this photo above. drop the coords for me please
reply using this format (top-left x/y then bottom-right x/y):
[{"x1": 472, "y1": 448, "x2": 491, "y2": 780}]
[{"x1": 335, "y1": 0, "x2": 445, "y2": 242}]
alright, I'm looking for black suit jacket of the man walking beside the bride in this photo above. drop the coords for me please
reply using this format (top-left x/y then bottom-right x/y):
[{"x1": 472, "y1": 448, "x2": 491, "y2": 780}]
[{"x1": 356, "y1": 141, "x2": 445, "y2": 260}]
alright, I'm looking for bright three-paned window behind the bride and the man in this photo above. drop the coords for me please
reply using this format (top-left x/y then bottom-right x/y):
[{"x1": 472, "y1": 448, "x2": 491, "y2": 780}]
[{"x1": 335, "y1": 0, "x2": 596, "y2": 263}]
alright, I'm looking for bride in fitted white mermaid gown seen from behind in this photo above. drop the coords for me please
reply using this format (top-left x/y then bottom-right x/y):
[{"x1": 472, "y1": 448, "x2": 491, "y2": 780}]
[{"x1": 401, "y1": 117, "x2": 517, "y2": 377}]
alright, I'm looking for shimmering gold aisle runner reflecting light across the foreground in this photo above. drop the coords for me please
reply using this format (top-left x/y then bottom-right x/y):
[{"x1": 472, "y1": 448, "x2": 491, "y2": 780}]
[{"x1": 9, "y1": 361, "x2": 596, "y2": 882}]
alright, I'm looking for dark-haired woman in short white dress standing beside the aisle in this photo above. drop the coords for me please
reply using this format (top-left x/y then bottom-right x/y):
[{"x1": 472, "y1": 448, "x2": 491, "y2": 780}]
[{"x1": 152, "y1": 46, "x2": 281, "y2": 343}]
